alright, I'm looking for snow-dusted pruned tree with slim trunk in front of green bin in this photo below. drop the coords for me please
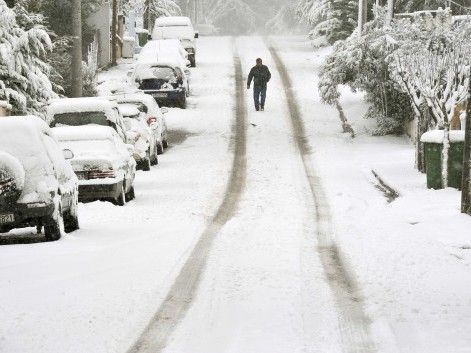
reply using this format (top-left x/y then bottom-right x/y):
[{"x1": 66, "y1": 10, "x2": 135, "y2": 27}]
[{"x1": 390, "y1": 11, "x2": 471, "y2": 187}]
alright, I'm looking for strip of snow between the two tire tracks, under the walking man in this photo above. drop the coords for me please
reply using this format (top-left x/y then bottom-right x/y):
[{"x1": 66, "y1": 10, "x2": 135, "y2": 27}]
[{"x1": 165, "y1": 37, "x2": 342, "y2": 353}]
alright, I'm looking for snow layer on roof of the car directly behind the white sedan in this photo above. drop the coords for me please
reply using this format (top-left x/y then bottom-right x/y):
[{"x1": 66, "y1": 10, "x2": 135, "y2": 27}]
[{"x1": 47, "y1": 97, "x2": 116, "y2": 122}]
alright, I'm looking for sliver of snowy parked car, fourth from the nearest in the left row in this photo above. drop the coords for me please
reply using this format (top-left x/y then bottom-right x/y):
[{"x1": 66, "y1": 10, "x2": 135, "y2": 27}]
[{"x1": 118, "y1": 103, "x2": 158, "y2": 171}]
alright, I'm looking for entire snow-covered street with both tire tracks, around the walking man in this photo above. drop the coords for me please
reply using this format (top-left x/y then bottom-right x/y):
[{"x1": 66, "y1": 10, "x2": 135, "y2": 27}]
[{"x1": 0, "y1": 37, "x2": 471, "y2": 353}]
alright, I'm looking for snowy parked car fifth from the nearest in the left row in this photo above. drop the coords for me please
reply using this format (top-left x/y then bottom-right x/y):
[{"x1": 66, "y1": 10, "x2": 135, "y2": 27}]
[{"x1": 113, "y1": 92, "x2": 168, "y2": 154}]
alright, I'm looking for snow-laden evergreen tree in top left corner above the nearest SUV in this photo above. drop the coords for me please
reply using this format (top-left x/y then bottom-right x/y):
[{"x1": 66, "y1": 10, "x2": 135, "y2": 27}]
[{"x1": 0, "y1": 0, "x2": 57, "y2": 115}]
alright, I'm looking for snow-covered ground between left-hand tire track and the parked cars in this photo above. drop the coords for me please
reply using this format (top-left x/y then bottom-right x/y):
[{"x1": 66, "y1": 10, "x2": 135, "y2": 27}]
[{"x1": 0, "y1": 38, "x2": 234, "y2": 353}]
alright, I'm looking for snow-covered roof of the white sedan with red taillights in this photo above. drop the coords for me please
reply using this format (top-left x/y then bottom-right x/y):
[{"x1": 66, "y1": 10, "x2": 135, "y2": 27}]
[{"x1": 52, "y1": 125, "x2": 116, "y2": 141}]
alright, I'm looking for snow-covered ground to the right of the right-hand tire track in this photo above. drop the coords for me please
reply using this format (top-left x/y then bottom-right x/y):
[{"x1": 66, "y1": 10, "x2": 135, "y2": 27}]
[{"x1": 273, "y1": 37, "x2": 471, "y2": 353}]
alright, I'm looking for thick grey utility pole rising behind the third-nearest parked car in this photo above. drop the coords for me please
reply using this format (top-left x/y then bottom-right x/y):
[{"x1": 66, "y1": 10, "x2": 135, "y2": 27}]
[{"x1": 71, "y1": 0, "x2": 83, "y2": 97}]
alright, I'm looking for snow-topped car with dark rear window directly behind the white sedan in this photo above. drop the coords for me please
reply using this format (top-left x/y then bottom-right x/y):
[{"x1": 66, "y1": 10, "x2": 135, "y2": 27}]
[{"x1": 47, "y1": 97, "x2": 128, "y2": 143}]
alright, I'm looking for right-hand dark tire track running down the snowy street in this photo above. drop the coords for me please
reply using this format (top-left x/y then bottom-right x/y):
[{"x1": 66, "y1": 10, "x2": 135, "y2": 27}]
[{"x1": 268, "y1": 44, "x2": 376, "y2": 353}]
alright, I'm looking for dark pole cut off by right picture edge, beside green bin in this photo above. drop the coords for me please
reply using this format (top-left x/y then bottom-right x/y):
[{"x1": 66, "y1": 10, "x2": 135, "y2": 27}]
[{"x1": 461, "y1": 69, "x2": 471, "y2": 216}]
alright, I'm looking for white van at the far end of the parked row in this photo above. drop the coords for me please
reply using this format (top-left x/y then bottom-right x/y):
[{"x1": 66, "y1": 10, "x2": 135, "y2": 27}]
[{"x1": 152, "y1": 16, "x2": 198, "y2": 67}]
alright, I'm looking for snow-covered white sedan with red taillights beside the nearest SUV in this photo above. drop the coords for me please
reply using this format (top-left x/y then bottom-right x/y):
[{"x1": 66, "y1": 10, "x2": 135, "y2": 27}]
[{"x1": 52, "y1": 125, "x2": 136, "y2": 206}]
